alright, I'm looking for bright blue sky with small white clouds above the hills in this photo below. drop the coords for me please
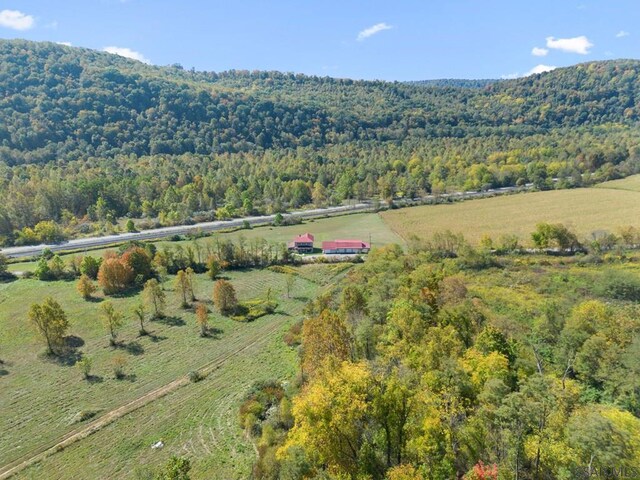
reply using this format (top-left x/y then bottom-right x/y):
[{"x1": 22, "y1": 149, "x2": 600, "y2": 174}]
[{"x1": 0, "y1": 0, "x2": 640, "y2": 80}]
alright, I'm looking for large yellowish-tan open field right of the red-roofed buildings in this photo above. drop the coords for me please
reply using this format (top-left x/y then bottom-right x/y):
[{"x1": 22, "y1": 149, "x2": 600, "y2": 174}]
[{"x1": 381, "y1": 181, "x2": 640, "y2": 244}]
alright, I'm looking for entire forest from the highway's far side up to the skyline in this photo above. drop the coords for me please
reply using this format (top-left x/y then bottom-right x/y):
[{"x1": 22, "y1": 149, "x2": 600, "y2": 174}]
[{"x1": 0, "y1": 40, "x2": 640, "y2": 244}]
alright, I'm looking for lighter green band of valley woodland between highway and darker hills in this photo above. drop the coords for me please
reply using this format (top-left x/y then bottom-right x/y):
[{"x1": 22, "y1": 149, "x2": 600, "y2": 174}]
[{"x1": 0, "y1": 126, "x2": 640, "y2": 245}]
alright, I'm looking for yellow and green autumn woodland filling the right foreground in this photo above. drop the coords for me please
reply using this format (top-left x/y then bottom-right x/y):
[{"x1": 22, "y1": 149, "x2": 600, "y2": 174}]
[{"x1": 246, "y1": 238, "x2": 640, "y2": 480}]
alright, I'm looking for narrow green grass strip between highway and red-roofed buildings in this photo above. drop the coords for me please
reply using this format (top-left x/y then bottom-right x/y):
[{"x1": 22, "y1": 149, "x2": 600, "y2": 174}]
[{"x1": 9, "y1": 213, "x2": 402, "y2": 272}]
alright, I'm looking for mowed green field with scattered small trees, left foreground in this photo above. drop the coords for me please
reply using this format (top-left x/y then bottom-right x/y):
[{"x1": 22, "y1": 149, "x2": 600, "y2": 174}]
[{"x1": 0, "y1": 265, "x2": 345, "y2": 479}]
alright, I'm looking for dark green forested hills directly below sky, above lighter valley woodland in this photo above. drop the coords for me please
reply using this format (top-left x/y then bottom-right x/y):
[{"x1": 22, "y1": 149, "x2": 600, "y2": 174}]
[{"x1": 0, "y1": 40, "x2": 640, "y2": 165}]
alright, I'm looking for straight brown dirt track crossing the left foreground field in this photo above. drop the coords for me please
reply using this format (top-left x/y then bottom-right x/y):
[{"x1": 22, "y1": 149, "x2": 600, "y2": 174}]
[{"x1": 0, "y1": 317, "x2": 286, "y2": 480}]
